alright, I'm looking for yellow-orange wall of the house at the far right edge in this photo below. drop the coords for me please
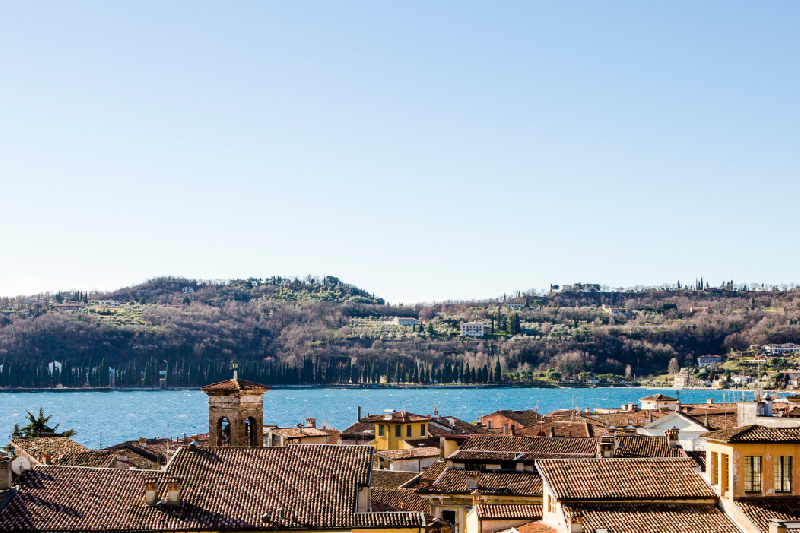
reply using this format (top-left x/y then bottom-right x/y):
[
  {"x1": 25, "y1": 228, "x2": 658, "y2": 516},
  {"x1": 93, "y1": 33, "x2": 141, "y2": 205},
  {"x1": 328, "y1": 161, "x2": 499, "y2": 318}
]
[{"x1": 706, "y1": 441, "x2": 800, "y2": 499}]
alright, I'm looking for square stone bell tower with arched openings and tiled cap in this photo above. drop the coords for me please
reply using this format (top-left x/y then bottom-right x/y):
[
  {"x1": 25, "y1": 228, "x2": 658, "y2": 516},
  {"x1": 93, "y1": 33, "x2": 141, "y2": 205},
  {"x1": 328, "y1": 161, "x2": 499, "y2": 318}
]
[{"x1": 202, "y1": 370, "x2": 269, "y2": 448}]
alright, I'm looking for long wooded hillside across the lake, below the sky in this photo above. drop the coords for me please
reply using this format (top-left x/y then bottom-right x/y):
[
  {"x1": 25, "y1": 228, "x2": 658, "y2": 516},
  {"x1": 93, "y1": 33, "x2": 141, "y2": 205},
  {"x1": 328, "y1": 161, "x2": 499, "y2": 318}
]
[{"x1": 0, "y1": 276, "x2": 800, "y2": 387}]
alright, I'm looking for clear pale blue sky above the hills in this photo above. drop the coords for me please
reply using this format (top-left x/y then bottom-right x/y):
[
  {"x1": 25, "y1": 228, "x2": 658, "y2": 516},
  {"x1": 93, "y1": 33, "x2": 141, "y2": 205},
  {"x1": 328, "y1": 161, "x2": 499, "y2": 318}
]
[{"x1": 0, "y1": 1, "x2": 800, "y2": 303}]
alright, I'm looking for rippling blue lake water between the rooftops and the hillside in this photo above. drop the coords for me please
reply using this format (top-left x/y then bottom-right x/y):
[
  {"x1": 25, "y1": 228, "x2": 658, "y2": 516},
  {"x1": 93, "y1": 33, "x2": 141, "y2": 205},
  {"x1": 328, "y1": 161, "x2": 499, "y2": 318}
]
[{"x1": 0, "y1": 387, "x2": 768, "y2": 448}]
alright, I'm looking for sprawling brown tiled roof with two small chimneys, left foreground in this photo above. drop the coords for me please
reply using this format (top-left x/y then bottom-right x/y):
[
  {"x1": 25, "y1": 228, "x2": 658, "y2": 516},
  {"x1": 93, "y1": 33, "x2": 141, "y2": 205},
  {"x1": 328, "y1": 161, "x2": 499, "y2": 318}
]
[{"x1": 0, "y1": 445, "x2": 425, "y2": 531}]
